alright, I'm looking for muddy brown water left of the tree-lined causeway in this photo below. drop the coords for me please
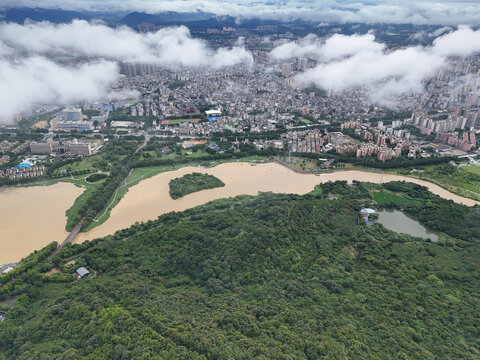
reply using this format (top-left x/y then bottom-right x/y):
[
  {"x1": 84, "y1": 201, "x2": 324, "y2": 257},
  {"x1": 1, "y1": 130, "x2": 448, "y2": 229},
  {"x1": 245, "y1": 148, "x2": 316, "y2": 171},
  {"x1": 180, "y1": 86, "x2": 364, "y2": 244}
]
[{"x1": 0, "y1": 182, "x2": 83, "y2": 264}]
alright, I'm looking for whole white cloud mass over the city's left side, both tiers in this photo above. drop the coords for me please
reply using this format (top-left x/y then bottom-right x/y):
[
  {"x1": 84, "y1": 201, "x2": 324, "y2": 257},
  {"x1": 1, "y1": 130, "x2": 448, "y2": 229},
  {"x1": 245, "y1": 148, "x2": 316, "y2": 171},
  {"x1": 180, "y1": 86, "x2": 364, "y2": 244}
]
[{"x1": 0, "y1": 20, "x2": 253, "y2": 122}]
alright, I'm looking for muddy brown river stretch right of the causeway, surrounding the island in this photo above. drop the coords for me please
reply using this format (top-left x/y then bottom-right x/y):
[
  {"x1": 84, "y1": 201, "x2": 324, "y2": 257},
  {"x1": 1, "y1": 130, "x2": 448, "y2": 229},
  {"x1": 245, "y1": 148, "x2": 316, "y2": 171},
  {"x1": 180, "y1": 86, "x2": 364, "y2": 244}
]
[{"x1": 75, "y1": 162, "x2": 476, "y2": 243}]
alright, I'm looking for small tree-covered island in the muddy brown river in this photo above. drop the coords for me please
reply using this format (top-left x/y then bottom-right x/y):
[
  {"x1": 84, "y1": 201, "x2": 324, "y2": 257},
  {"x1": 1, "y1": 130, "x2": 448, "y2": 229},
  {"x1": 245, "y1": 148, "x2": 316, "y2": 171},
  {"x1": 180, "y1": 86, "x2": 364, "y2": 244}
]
[{"x1": 168, "y1": 172, "x2": 225, "y2": 199}]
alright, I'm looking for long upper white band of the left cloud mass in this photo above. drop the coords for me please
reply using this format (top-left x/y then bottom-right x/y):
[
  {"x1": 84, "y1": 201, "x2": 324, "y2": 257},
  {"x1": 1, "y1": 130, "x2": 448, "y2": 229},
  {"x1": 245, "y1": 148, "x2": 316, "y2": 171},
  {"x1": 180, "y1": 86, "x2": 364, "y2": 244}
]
[{"x1": 0, "y1": 20, "x2": 253, "y2": 67}]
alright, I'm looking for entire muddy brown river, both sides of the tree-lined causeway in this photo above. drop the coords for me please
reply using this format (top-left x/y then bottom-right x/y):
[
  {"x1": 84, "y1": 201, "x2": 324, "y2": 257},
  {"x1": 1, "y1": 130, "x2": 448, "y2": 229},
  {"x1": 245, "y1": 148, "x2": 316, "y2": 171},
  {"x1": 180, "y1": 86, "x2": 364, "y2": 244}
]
[{"x1": 0, "y1": 162, "x2": 476, "y2": 264}]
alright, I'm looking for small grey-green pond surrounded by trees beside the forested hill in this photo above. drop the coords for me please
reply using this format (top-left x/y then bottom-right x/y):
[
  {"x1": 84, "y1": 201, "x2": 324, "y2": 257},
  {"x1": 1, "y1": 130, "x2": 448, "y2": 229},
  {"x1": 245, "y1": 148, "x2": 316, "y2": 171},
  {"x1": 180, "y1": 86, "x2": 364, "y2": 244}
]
[{"x1": 378, "y1": 210, "x2": 438, "y2": 241}]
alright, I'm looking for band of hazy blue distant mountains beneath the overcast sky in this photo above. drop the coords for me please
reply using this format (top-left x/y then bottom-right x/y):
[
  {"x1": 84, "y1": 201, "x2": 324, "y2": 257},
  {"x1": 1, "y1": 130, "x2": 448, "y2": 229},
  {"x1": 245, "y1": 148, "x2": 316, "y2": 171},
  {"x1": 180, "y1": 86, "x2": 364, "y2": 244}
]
[{"x1": 0, "y1": 6, "x2": 440, "y2": 46}]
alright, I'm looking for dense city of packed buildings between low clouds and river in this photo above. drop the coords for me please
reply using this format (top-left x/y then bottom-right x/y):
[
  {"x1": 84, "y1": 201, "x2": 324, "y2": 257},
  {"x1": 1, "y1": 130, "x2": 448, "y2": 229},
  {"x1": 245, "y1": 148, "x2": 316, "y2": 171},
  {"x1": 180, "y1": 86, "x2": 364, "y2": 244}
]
[{"x1": 0, "y1": 24, "x2": 480, "y2": 183}]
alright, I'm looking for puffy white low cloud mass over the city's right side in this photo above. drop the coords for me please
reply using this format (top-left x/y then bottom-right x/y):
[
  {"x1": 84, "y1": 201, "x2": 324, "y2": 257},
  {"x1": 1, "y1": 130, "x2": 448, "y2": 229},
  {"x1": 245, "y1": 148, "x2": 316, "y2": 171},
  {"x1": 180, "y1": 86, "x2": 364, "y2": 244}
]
[{"x1": 271, "y1": 27, "x2": 480, "y2": 104}]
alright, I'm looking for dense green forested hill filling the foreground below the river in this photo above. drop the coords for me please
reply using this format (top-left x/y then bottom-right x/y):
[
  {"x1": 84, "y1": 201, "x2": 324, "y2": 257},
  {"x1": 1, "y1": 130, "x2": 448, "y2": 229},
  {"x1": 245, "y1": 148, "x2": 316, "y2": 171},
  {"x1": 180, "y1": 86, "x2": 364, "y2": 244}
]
[{"x1": 0, "y1": 183, "x2": 480, "y2": 360}]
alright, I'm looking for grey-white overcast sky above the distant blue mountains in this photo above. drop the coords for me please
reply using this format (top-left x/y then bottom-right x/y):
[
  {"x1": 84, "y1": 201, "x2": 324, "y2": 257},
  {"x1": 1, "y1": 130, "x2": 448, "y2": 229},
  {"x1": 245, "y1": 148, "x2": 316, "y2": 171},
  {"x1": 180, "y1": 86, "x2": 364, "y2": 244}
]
[{"x1": 1, "y1": 0, "x2": 480, "y2": 26}]
